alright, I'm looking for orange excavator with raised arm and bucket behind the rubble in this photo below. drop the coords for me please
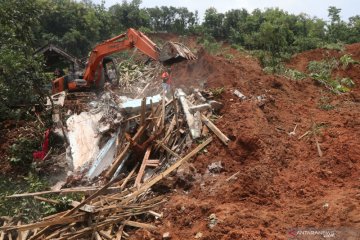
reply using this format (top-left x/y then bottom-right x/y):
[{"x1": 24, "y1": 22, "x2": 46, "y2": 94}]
[{"x1": 52, "y1": 28, "x2": 196, "y2": 94}]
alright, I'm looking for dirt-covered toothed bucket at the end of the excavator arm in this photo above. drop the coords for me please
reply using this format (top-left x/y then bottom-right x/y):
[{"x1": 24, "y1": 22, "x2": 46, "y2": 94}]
[{"x1": 159, "y1": 41, "x2": 196, "y2": 62}]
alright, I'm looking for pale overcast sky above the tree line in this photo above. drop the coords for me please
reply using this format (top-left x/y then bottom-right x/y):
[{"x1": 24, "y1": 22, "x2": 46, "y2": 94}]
[{"x1": 93, "y1": 0, "x2": 360, "y2": 20}]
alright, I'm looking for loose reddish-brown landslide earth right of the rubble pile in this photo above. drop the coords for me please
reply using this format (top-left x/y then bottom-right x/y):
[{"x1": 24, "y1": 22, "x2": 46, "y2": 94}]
[{"x1": 129, "y1": 44, "x2": 360, "y2": 240}]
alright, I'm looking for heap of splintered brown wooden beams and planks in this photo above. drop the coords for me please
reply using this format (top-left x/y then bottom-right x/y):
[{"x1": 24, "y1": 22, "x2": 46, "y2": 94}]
[{"x1": 0, "y1": 87, "x2": 229, "y2": 240}]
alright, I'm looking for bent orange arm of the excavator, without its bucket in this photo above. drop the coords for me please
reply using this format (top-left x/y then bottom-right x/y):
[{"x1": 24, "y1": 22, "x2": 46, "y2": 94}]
[{"x1": 84, "y1": 28, "x2": 160, "y2": 84}]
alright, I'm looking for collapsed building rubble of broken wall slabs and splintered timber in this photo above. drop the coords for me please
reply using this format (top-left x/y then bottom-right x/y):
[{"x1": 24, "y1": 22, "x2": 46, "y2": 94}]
[{"x1": 0, "y1": 59, "x2": 229, "y2": 239}]
